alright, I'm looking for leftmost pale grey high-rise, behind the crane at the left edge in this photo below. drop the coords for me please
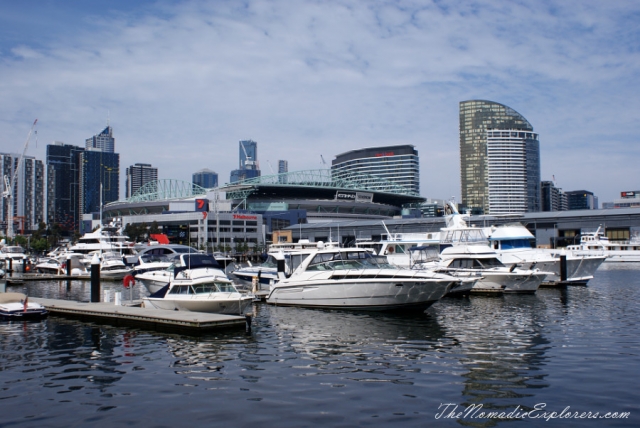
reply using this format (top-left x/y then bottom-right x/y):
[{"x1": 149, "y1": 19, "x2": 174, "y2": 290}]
[{"x1": 0, "y1": 154, "x2": 45, "y2": 233}]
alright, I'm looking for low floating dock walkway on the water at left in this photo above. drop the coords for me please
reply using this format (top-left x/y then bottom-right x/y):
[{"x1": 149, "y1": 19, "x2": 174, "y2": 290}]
[{"x1": 29, "y1": 297, "x2": 251, "y2": 334}]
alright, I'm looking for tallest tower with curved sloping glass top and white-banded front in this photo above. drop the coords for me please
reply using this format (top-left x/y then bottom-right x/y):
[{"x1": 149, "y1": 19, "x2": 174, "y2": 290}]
[{"x1": 460, "y1": 100, "x2": 540, "y2": 214}]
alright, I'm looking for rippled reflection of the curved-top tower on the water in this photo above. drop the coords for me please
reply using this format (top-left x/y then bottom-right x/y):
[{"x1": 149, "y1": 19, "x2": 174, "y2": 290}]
[{"x1": 435, "y1": 295, "x2": 550, "y2": 422}]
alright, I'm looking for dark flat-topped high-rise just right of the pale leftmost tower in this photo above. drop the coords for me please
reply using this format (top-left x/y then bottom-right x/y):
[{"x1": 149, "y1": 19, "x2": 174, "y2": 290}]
[{"x1": 47, "y1": 141, "x2": 84, "y2": 231}]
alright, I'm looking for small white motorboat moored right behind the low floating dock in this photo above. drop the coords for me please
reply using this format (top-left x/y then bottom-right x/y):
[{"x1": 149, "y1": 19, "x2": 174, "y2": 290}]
[{"x1": 142, "y1": 255, "x2": 253, "y2": 315}]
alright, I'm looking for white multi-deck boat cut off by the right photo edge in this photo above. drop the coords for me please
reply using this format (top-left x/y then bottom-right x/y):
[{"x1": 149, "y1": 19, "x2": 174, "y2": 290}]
[{"x1": 567, "y1": 227, "x2": 640, "y2": 263}]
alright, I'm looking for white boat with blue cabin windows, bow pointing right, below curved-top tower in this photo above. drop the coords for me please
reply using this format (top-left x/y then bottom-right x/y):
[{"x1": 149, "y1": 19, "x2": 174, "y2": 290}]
[{"x1": 484, "y1": 223, "x2": 606, "y2": 285}]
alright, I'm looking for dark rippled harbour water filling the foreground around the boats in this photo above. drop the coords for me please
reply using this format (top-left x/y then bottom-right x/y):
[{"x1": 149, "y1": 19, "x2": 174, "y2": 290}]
[{"x1": 0, "y1": 265, "x2": 640, "y2": 427}]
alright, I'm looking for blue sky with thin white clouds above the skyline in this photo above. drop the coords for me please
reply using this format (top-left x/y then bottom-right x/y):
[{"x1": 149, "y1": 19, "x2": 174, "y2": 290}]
[{"x1": 0, "y1": 0, "x2": 640, "y2": 203}]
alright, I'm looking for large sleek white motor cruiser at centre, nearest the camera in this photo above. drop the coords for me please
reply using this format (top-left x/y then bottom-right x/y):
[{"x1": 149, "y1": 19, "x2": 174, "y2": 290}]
[{"x1": 267, "y1": 242, "x2": 459, "y2": 311}]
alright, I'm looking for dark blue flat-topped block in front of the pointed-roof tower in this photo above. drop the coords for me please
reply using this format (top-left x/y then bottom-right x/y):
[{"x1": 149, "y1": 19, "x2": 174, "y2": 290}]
[{"x1": 79, "y1": 150, "x2": 120, "y2": 214}]
